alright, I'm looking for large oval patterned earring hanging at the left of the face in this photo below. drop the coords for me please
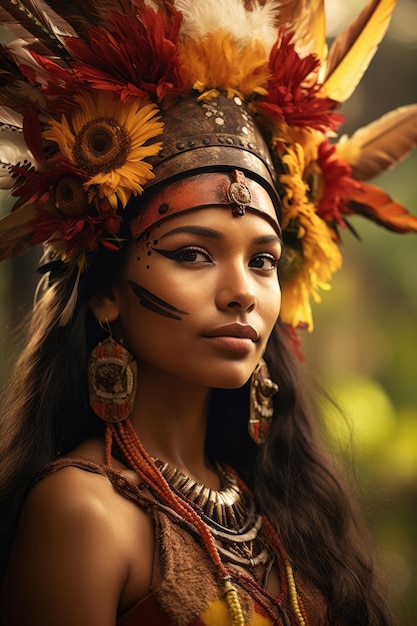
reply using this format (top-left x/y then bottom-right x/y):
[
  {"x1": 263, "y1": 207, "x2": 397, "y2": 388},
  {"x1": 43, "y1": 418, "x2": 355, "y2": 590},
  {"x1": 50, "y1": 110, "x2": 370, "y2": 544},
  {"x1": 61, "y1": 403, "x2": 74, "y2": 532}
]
[{"x1": 88, "y1": 318, "x2": 137, "y2": 423}]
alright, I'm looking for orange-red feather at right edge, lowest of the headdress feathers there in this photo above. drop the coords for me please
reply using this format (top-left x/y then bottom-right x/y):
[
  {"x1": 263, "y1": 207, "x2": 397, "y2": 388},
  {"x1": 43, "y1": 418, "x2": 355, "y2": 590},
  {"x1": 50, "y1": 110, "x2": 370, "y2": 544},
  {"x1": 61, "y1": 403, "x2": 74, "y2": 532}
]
[{"x1": 349, "y1": 183, "x2": 417, "y2": 233}]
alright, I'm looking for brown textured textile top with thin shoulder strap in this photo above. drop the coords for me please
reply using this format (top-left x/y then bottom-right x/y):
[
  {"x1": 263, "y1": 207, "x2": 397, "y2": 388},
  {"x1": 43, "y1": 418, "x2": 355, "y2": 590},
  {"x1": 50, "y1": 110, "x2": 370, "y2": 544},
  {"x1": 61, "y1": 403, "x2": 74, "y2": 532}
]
[{"x1": 37, "y1": 458, "x2": 329, "y2": 626}]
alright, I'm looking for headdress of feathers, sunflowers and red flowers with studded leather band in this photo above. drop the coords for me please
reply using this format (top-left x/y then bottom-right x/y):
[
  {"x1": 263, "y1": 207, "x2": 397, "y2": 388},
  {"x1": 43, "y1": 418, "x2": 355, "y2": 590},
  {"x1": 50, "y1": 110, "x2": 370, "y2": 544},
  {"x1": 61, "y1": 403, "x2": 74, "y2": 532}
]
[{"x1": 0, "y1": 0, "x2": 417, "y2": 327}]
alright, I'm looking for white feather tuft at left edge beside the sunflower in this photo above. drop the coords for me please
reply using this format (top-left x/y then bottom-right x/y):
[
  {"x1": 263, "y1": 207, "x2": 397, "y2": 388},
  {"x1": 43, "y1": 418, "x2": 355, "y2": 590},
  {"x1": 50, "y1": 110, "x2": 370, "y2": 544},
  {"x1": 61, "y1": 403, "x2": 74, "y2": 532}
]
[{"x1": 0, "y1": 125, "x2": 37, "y2": 189}]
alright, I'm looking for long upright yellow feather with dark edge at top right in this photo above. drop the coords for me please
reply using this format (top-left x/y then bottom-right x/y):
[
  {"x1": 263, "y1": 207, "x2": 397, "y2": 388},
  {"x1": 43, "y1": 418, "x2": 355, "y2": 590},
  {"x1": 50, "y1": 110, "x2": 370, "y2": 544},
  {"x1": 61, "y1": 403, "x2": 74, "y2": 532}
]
[{"x1": 320, "y1": 0, "x2": 396, "y2": 102}]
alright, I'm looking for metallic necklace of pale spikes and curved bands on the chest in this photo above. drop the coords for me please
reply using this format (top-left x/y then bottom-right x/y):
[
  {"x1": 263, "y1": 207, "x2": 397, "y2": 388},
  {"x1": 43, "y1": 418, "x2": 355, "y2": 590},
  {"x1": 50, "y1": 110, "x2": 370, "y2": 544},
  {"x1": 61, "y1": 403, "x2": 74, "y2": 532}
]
[{"x1": 155, "y1": 459, "x2": 274, "y2": 586}]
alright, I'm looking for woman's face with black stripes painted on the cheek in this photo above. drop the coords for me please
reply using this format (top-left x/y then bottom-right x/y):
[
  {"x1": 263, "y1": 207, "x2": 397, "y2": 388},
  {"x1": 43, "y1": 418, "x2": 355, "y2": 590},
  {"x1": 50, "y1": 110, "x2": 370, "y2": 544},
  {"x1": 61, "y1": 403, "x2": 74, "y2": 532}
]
[{"x1": 115, "y1": 203, "x2": 281, "y2": 388}]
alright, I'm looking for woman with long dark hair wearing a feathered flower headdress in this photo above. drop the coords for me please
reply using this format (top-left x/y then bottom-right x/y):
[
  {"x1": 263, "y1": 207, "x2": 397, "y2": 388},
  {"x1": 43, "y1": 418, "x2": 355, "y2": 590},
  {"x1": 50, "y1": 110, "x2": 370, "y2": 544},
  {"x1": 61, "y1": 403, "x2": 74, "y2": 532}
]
[{"x1": 0, "y1": 2, "x2": 416, "y2": 626}]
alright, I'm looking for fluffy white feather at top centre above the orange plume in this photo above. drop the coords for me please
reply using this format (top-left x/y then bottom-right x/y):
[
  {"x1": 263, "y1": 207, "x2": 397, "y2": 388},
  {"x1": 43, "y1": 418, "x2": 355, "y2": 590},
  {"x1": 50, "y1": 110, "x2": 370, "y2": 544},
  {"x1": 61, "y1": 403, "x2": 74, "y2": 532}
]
[{"x1": 175, "y1": 0, "x2": 280, "y2": 53}]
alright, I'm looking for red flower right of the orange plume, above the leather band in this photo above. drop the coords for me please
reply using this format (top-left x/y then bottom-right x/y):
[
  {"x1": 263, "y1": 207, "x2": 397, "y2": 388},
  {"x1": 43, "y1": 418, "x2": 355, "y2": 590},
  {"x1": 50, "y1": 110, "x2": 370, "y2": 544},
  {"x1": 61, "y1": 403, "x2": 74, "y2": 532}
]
[{"x1": 256, "y1": 31, "x2": 343, "y2": 132}]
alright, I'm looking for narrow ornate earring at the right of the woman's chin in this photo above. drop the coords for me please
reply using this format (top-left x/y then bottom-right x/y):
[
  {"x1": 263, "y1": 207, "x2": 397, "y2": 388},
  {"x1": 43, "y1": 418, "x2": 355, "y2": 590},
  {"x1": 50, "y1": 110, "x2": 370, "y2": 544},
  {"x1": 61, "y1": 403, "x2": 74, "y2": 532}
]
[{"x1": 248, "y1": 359, "x2": 278, "y2": 443}]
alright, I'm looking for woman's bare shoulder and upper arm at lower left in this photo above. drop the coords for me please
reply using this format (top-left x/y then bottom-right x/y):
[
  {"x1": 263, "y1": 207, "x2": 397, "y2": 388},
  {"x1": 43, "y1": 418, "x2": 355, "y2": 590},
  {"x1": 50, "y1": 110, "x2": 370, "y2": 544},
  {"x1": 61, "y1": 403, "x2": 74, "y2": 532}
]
[{"x1": 3, "y1": 444, "x2": 153, "y2": 626}]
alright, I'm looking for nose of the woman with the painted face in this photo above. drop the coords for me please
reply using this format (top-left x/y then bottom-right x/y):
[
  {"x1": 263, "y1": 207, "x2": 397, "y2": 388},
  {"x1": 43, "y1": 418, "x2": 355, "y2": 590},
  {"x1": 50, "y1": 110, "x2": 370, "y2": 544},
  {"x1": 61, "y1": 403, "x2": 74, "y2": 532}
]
[{"x1": 216, "y1": 266, "x2": 256, "y2": 312}]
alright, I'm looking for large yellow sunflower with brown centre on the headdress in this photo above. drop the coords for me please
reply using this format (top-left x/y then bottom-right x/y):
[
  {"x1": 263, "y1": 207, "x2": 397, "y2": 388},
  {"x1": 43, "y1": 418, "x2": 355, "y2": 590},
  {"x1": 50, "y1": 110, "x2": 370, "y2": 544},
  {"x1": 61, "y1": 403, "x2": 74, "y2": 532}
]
[{"x1": 44, "y1": 91, "x2": 163, "y2": 208}]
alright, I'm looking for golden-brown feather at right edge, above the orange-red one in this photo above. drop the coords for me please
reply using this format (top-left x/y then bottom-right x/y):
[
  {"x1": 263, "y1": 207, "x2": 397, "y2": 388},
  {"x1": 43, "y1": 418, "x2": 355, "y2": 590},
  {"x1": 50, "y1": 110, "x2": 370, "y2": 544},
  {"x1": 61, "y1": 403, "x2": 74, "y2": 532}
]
[{"x1": 338, "y1": 104, "x2": 417, "y2": 180}]
